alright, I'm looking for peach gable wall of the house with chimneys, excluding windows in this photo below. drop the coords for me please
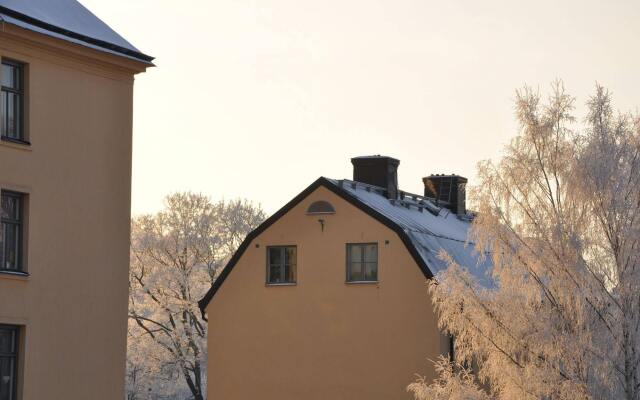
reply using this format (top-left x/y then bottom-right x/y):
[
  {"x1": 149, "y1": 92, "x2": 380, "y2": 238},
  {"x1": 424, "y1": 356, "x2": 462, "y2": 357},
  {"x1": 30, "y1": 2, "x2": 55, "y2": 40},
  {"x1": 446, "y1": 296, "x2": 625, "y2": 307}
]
[{"x1": 206, "y1": 187, "x2": 447, "y2": 400}]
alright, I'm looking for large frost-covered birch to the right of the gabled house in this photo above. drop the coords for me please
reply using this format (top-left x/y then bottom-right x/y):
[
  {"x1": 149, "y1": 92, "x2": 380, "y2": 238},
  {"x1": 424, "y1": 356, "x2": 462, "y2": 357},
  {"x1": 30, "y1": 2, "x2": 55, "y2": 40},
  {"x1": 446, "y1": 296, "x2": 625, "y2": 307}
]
[{"x1": 409, "y1": 82, "x2": 640, "y2": 400}]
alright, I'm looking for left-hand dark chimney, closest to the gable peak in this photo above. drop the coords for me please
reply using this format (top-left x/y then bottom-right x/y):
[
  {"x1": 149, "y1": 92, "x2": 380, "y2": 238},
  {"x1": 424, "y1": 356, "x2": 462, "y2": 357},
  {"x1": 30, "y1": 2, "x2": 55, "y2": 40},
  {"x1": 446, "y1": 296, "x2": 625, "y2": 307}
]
[{"x1": 351, "y1": 155, "x2": 400, "y2": 199}]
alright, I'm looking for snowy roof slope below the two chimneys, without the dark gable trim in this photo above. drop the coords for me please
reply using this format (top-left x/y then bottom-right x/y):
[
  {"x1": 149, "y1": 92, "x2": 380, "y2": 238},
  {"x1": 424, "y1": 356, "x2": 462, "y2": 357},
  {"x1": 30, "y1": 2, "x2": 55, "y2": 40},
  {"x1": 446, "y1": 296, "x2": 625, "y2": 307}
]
[{"x1": 328, "y1": 179, "x2": 493, "y2": 287}]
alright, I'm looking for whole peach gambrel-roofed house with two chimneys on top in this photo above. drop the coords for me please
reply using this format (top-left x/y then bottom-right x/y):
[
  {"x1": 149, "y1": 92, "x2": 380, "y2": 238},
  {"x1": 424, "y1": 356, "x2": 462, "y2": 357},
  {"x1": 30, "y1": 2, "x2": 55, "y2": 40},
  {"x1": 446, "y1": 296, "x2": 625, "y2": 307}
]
[{"x1": 200, "y1": 156, "x2": 485, "y2": 400}]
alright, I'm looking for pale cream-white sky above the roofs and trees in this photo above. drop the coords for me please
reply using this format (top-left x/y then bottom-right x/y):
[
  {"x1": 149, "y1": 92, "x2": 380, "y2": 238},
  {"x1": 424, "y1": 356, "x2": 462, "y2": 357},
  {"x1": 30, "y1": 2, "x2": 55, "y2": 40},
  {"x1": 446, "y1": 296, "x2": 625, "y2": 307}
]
[{"x1": 81, "y1": 0, "x2": 640, "y2": 214}]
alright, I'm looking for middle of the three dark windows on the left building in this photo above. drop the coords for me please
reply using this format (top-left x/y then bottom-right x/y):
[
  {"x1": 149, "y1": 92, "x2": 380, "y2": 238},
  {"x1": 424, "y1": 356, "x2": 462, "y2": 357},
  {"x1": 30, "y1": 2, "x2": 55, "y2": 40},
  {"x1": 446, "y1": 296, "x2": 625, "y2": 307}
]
[{"x1": 0, "y1": 190, "x2": 24, "y2": 271}]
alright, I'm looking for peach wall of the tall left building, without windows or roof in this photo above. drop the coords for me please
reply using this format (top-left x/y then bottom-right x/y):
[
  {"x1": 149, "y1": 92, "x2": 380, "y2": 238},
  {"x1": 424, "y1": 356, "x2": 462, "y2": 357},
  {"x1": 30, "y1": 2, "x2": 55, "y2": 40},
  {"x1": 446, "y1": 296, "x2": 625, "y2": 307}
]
[{"x1": 0, "y1": 25, "x2": 143, "y2": 400}]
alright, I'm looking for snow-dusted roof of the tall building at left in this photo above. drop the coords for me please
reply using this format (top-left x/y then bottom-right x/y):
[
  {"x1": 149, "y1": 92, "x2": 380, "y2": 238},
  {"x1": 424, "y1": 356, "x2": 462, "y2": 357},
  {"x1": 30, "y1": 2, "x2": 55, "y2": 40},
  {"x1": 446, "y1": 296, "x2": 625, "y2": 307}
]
[{"x1": 0, "y1": 0, "x2": 153, "y2": 63}]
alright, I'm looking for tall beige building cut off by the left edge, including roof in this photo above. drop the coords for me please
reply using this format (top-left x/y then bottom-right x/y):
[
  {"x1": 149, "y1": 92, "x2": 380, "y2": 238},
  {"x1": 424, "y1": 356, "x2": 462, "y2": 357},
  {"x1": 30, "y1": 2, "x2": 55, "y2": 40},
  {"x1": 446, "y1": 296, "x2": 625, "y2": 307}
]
[{"x1": 0, "y1": 0, "x2": 152, "y2": 400}]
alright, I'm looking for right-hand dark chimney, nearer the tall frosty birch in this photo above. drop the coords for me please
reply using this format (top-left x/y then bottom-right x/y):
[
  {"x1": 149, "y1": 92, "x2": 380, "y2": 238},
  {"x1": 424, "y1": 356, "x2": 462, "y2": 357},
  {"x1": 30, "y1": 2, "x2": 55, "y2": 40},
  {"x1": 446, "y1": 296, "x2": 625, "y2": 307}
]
[{"x1": 422, "y1": 174, "x2": 467, "y2": 215}]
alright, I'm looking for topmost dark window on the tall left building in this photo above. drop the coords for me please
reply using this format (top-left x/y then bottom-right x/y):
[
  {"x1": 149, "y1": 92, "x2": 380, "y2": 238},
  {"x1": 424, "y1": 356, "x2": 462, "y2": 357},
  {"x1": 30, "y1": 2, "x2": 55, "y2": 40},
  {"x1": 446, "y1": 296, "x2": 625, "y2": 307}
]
[{"x1": 0, "y1": 59, "x2": 25, "y2": 141}]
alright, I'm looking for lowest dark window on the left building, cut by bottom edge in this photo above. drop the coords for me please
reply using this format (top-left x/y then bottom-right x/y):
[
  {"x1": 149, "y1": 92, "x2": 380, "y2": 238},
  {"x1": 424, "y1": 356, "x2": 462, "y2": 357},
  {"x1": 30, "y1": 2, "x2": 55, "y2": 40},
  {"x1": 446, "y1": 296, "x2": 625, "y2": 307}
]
[{"x1": 0, "y1": 325, "x2": 19, "y2": 400}]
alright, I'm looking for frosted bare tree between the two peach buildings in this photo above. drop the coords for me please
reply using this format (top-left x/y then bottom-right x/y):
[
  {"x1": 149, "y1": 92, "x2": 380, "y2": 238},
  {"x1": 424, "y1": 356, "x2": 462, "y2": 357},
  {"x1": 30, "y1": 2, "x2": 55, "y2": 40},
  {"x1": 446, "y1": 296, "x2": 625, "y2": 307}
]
[{"x1": 127, "y1": 193, "x2": 265, "y2": 400}]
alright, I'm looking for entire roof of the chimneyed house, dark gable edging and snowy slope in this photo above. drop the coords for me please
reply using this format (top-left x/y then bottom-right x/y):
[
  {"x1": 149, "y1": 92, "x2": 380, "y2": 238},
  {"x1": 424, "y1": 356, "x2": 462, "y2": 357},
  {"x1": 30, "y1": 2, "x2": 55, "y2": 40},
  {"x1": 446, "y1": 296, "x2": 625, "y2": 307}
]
[{"x1": 198, "y1": 177, "x2": 490, "y2": 316}]
